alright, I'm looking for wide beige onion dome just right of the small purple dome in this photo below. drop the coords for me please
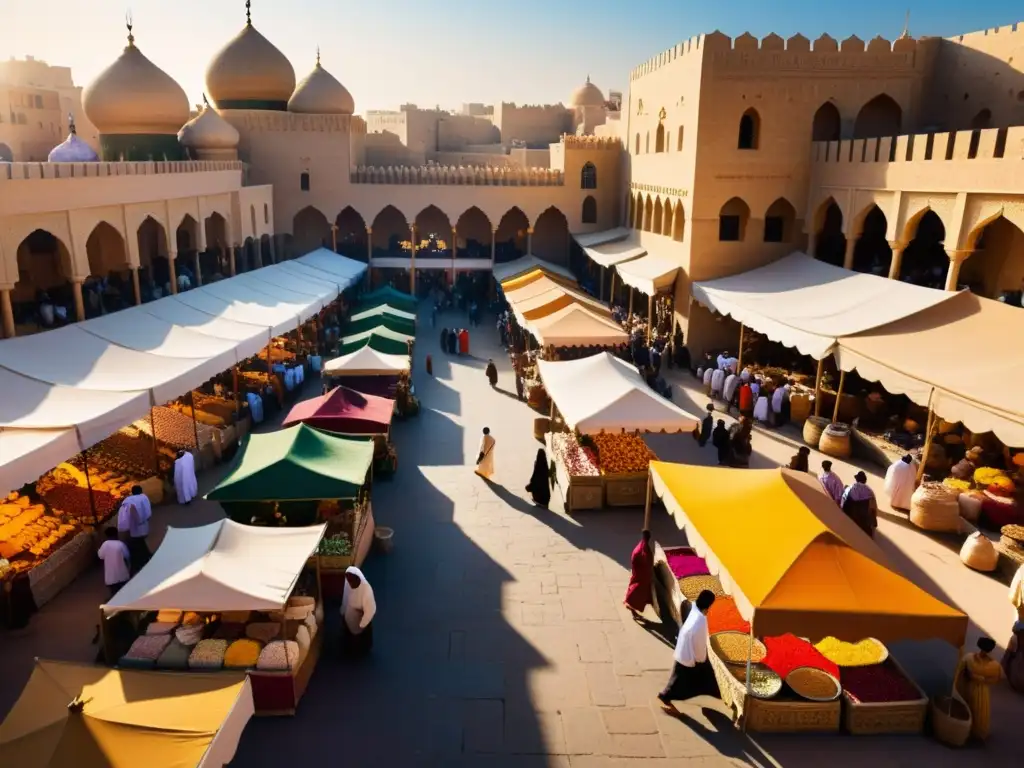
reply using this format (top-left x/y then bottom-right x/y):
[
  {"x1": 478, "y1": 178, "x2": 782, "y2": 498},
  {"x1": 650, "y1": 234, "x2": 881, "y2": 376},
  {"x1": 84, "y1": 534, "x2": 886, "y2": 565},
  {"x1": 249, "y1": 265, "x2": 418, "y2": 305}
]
[{"x1": 82, "y1": 31, "x2": 188, "y2": 135}]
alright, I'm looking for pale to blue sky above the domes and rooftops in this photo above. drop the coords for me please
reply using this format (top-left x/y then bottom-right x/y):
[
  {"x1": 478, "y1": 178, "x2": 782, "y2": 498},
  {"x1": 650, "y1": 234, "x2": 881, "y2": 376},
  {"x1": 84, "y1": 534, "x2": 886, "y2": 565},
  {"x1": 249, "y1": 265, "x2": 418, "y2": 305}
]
[{"x1": 0, "y1": 0, "x2": 1024, "y2": 112}]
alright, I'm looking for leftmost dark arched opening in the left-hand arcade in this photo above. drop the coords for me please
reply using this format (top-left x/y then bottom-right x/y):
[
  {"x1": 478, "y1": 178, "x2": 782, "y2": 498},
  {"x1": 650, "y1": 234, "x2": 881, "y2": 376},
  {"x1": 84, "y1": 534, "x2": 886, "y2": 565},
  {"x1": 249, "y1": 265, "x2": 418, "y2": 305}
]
[{"x1": 11, "y1": 229, "x2": 76, "y2": 336}]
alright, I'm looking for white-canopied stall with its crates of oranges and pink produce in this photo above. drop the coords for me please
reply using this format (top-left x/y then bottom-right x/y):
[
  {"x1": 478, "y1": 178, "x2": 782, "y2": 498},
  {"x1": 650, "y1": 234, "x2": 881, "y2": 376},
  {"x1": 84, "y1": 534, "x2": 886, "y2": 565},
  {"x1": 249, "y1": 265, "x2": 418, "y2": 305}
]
[{"x1": 537, "y1": 352, "x2": 698, "y2": 510}]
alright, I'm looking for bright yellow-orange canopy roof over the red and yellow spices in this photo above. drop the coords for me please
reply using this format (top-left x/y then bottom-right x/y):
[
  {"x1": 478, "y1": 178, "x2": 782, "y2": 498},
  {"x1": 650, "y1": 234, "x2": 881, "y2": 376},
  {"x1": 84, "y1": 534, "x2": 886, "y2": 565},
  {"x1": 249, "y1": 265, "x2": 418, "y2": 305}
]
[{"x1": 650, "y1": 462, "x2": 968, "y2": 647}]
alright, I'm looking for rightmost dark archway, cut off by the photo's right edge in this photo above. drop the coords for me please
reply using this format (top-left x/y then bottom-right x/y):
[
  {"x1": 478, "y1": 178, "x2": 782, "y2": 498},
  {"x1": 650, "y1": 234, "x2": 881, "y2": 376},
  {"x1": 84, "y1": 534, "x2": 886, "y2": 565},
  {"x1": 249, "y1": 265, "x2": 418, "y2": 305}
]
[{"x1": 959, "y1": 216, "x2": 1024, "y2": 306}]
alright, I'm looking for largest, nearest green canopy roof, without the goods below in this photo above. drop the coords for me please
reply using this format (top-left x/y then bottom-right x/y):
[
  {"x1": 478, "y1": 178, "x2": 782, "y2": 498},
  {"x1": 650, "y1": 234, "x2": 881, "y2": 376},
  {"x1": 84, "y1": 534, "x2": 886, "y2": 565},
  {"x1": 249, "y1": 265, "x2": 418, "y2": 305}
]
[{"x1": 206, "y1": 424, "x2": 374, "y2": 502}]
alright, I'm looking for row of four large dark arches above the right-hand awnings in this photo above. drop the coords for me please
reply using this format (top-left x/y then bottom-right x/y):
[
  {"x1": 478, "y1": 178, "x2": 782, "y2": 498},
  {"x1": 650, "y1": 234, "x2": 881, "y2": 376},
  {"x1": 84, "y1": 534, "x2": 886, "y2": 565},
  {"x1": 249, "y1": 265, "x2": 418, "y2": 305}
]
[{"x1": 809, "y1": 198, "x2": 1024, "y2": 305}]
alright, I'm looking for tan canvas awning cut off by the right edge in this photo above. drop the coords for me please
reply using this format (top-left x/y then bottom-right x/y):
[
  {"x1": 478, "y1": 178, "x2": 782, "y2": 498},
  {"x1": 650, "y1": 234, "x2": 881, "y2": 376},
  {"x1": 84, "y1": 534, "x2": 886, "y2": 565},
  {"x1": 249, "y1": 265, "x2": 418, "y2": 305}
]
[{"x1": 836, "y1": 290, "x2": 1024, "y2": 447}]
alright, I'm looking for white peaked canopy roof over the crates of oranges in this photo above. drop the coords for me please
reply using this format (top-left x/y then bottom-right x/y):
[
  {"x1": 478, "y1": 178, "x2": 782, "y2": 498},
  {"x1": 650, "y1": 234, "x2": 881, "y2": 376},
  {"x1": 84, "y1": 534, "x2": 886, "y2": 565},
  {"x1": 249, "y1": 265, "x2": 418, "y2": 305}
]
[{"x1": 537, "y1": 352, "x2": 697, "y2": 434}]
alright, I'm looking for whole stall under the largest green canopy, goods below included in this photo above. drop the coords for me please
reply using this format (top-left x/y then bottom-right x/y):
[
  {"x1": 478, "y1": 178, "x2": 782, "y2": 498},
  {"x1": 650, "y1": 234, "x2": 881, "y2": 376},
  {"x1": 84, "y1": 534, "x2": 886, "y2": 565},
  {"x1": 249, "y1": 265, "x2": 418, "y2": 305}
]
[{"x1": 206, "y1": 424, "x2": 374, "y2": 585}]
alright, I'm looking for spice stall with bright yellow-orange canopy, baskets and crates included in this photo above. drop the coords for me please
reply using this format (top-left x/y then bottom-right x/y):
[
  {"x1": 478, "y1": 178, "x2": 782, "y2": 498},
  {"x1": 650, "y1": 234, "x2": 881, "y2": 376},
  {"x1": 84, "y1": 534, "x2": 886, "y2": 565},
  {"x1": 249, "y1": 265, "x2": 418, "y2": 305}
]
[{"x1": 645, "y1": 462, "x2": 968, "y2": 733}]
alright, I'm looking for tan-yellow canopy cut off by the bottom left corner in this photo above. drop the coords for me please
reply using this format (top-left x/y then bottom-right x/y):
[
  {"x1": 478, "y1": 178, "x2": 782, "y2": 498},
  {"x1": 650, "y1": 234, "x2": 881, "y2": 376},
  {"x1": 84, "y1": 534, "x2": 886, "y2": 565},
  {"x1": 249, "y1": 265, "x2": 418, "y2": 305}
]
[{"x1": 0, "y1": 659, "x2": 253, "y2": 768}]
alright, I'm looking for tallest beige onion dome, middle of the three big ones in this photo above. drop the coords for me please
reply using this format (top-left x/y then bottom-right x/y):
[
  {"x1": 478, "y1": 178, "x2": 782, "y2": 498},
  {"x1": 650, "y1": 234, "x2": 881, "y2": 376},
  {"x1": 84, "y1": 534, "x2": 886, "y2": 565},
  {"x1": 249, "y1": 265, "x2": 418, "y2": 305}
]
[{"x1": 206, "y1": 2, "x2": 295, "y2": 111}]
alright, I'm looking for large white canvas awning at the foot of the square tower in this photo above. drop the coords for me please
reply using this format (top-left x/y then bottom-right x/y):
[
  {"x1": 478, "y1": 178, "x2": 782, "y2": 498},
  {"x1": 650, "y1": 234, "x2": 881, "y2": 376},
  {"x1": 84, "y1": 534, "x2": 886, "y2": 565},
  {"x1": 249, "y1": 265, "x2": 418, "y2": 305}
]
[{"x1": 693, "y1": 253, "x2": 953, "y2": 359}]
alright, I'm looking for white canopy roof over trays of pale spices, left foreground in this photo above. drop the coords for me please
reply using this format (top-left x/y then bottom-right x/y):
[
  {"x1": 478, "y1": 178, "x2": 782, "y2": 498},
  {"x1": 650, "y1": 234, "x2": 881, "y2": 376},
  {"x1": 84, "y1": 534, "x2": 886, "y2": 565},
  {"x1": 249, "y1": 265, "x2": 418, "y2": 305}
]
[{"x1": 102, "y1": 520, "x2": 321, "y2": 615}]
